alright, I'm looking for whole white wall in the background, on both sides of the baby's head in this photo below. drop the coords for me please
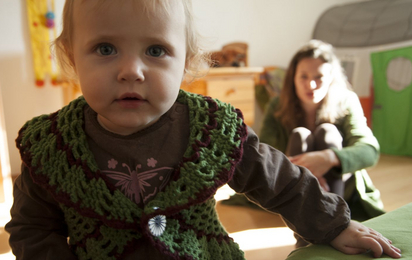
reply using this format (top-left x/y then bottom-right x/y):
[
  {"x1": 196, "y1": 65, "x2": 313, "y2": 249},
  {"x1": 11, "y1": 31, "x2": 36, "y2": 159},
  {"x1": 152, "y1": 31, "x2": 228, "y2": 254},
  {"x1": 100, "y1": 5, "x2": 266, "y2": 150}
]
[{"x1": 0, "y1": 0, "x2": 361, "y2": 174}]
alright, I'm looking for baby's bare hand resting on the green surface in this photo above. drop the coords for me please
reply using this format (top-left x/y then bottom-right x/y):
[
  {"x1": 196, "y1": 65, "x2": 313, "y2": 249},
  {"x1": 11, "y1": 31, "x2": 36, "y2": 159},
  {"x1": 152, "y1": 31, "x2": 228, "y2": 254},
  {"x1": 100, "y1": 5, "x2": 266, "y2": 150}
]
[{"x1": 330, "y1": 221, "x2": 401, "y2": 258}]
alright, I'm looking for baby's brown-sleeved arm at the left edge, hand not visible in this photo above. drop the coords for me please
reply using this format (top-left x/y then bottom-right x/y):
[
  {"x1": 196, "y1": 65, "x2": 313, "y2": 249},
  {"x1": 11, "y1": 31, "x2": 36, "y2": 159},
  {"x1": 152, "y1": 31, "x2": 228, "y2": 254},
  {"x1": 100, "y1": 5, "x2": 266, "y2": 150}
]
[{"x1": 5, "y1": 167, "x2": 77, "y2": 260}]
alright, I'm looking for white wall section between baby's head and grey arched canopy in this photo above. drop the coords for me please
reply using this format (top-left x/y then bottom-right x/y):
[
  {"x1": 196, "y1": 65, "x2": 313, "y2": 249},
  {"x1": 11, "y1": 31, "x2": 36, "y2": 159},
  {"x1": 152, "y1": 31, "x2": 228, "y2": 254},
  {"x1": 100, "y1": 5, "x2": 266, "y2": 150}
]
[{"x1": 193, "y1": 0, "x2": 362, "y2": 67}]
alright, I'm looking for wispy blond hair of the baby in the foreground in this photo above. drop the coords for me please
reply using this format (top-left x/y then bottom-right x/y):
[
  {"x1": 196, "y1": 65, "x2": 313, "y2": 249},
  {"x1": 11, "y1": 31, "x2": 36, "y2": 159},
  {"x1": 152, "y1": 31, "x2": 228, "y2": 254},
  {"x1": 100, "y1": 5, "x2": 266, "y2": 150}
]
[{"x1": 53, "y1": 0, "x2": 210, "y2": 82}]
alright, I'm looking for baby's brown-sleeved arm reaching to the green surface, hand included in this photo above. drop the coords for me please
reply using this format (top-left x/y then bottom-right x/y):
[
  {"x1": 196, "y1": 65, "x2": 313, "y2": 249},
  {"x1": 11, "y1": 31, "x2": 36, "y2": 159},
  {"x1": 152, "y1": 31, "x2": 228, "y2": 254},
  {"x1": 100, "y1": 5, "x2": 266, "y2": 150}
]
[{"x1": 233, "y1": 126, "x2": 400, "y2": 258}]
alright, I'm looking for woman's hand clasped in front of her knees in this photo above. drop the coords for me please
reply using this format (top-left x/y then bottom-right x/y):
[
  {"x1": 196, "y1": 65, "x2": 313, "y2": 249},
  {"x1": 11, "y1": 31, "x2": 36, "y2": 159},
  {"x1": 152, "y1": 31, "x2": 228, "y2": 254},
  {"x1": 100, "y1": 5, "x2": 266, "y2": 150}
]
[{"x1": 289, "y1": 149, "x2": 340, "y2": 178}]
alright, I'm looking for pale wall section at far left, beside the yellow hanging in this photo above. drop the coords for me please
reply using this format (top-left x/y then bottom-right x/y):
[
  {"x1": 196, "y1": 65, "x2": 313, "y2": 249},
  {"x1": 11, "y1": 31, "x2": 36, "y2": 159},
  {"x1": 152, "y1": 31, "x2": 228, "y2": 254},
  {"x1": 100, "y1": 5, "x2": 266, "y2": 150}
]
[{"x1": 0, "y1": 0, "x2": 63, "y2": 174}]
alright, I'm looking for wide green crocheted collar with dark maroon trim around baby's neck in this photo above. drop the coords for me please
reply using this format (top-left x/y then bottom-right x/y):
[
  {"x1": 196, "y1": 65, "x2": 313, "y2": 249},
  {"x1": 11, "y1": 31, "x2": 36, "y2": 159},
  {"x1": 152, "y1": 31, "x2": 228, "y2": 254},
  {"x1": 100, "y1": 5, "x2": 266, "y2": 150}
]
[{"x1": 16, "y1": 91, "x2": 247, "y2": 231}]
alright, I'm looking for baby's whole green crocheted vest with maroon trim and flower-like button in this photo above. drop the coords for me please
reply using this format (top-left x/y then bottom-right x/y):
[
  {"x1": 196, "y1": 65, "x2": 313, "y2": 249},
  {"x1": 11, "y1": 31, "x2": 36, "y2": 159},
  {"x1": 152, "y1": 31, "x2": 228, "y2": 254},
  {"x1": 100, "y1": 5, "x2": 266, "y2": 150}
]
[{"x1": 16, "y1": 91, "x2": 247, "y2": 260}]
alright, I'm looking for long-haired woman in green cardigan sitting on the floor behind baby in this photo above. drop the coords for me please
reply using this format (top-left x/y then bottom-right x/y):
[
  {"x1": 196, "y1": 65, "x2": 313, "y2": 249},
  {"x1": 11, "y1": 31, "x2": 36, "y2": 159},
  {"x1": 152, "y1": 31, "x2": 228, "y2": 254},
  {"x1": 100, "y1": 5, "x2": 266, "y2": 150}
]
[{"x1": 260, "y1": 40, "x2": 384, "y2": 224}]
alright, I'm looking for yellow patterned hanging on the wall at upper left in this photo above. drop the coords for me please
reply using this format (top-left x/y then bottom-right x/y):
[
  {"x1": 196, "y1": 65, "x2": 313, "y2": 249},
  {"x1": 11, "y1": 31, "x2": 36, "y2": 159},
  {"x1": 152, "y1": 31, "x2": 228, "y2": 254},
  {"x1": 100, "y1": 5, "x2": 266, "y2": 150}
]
[{"x1": 27, "y1": 0, "x2": 59, "y2": 87}]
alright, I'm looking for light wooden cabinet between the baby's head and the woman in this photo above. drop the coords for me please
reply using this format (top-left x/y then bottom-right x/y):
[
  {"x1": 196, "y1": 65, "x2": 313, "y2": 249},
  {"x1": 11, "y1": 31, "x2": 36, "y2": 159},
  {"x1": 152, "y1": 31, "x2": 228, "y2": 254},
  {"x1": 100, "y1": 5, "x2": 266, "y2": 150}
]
[{"x1": 181, "y1": 67, "x2": 263, "y2": 126}]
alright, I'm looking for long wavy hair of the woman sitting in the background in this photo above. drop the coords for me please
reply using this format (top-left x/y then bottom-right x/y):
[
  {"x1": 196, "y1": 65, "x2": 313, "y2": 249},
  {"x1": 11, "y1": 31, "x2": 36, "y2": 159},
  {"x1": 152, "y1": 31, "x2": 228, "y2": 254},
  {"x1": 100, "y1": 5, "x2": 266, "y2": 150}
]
[{"x1": 274, "y1": 40, "x2": 351, "y2": 131}]
